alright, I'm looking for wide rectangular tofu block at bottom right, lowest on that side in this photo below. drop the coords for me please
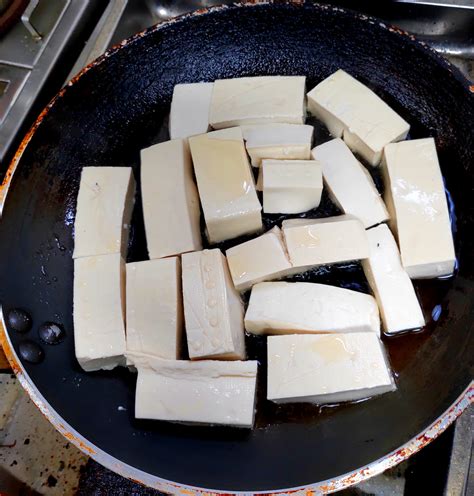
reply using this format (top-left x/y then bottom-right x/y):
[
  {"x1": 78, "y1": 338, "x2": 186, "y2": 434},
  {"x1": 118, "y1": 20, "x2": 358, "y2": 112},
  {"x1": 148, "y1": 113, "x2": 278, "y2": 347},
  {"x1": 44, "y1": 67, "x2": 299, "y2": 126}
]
[{"x1": 267, "y1": 332, "x2": 396, "y2": 405}]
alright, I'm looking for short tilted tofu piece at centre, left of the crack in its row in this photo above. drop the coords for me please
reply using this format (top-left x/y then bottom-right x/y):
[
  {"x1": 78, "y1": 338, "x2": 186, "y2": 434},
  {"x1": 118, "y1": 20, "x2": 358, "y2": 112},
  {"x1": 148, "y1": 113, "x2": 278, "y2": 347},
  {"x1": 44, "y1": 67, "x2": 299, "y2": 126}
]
[{"x1": 226, "y1": 227, "x2": 294, "y2": 291}]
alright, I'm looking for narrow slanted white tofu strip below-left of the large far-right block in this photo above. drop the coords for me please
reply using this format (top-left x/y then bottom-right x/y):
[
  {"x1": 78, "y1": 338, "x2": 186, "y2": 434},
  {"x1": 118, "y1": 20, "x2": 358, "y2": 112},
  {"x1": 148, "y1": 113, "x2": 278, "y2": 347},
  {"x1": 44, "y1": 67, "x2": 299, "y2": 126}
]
[{"x1": 362, "y1": 224, "x2": 425, "y2": 334}]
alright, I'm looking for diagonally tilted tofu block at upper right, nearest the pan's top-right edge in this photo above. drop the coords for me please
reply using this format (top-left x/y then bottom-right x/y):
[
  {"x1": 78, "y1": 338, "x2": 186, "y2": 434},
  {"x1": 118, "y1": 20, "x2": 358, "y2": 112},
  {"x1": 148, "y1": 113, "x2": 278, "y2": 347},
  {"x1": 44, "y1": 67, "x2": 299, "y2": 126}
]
[{"x1": 307, "y1": 69, "x2": 410, "y2": 166}]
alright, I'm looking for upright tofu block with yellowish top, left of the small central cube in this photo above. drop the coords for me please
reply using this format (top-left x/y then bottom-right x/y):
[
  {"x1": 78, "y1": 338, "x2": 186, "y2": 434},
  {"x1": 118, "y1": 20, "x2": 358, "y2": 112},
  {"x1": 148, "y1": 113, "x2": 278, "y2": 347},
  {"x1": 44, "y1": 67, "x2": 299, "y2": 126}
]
[{"x1": 189, "y1": 127, "x2": 262, "y2": 243}]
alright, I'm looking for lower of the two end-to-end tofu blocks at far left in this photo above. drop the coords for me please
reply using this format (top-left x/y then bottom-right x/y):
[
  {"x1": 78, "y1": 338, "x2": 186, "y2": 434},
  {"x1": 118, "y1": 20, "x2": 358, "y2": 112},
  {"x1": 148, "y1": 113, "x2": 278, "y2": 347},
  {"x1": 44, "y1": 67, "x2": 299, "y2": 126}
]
[{"x1": 74, "y1": 253, "x2": 125, "y2": 372}]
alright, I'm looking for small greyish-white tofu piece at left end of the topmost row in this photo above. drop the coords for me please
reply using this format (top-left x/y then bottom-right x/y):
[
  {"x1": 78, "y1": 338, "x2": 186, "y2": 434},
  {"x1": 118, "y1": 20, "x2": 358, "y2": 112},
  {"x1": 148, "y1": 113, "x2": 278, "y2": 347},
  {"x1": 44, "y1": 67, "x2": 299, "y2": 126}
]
[{"x1": 169, "y1": 83, "x2": 214, "y2": 140}]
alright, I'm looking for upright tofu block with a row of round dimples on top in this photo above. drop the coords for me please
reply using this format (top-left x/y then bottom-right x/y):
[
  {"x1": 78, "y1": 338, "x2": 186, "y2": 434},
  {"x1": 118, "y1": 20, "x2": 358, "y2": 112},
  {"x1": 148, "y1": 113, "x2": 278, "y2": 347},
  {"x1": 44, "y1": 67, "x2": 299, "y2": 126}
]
[{"x1": 181, "y1": 249, "x2": 245, "y2": 360}]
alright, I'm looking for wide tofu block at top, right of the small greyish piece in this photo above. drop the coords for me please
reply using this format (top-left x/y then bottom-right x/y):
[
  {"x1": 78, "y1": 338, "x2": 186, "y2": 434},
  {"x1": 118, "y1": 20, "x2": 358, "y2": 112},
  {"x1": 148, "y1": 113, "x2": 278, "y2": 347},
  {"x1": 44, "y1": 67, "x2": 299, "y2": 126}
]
[{"x1": 209, "y1": 76, "x2": 306, "y2": 129}]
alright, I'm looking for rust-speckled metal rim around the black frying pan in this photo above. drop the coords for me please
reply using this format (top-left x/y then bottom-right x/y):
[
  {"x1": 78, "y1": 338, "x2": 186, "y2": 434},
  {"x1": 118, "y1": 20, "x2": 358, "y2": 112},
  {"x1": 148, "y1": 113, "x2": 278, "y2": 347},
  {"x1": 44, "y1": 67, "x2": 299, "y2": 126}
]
[{"x1": 0, "y1": 0, "x2": 474, "y2": 496}]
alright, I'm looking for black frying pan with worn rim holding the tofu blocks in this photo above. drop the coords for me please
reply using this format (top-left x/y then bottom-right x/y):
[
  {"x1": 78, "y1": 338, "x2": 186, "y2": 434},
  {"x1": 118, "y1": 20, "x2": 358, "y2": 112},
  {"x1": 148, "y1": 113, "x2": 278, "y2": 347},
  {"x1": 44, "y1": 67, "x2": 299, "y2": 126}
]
[{"x1": 0, "y1": 5, "x2": 474, "y2": 491}]
